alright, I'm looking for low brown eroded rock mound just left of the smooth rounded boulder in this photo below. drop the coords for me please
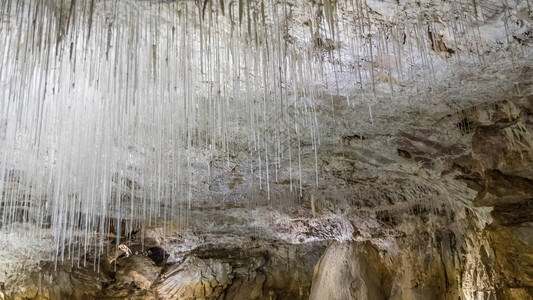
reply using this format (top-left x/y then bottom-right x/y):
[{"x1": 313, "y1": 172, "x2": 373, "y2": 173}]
[{"x1": 155, "y1": 243, "x2": 325, "y2": 299}]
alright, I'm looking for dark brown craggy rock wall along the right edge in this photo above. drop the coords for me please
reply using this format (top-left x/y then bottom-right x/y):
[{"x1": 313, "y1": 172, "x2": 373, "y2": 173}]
[{"x1": 472, "y1": 97, "x2": 533, "y2": 299}]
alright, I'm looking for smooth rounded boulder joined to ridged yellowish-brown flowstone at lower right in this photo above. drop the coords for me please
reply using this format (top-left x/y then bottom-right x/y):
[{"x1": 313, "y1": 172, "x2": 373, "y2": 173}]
[{"x1": 310, "y1": 207, "x2": 497, "y2": 299}]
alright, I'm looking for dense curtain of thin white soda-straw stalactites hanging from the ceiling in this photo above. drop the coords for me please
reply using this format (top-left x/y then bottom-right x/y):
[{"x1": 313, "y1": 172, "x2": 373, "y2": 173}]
[{"x1": 0, "y1": 0, "x2": 529, "y2": 261}]
